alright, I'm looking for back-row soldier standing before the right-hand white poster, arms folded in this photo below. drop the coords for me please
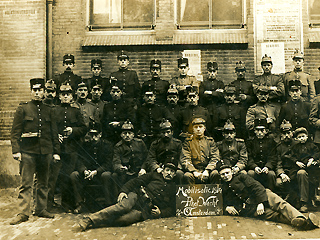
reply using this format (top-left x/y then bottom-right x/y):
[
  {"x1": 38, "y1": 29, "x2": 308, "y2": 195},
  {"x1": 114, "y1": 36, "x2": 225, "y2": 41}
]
[{"x1": 253, "y1": 54, "x2": 285, "y2": 110}]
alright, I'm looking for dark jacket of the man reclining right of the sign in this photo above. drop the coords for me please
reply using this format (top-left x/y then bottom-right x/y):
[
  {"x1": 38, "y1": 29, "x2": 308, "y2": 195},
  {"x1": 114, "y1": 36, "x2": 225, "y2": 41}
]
[{"x1": 222, "y1": 173, "x2": 269, "y2": 216}]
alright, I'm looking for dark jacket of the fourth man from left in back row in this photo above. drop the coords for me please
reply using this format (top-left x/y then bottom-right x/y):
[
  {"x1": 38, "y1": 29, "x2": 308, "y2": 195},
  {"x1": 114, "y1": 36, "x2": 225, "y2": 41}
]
[{"x1": 142, "y1": 78, "x2": 170, "y2": 105}]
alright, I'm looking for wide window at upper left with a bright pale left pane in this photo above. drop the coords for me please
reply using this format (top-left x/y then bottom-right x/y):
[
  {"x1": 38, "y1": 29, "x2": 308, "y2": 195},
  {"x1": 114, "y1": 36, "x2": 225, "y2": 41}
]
[{"x1": 88, "y1": 0, "x2": 156, "y2": 30}]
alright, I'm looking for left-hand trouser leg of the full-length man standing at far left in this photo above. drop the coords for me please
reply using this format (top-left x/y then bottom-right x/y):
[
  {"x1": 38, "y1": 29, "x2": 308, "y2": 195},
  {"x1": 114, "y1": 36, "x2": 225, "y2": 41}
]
[{"x1": 18, "y1": 153, "x2": 36, "y2": 216}]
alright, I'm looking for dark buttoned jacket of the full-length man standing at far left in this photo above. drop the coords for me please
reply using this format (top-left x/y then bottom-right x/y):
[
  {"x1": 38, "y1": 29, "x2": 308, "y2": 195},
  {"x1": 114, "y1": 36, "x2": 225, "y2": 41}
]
[{"x1": 11, "y1": 100, "x2": 60, "y2": 154}]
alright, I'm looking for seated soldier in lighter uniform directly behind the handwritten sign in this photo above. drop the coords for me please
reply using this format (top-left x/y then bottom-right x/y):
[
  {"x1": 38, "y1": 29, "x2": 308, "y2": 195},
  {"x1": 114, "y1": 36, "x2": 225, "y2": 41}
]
[{"x1": 180, "y1": 118, "x2": 220, "y2": 184}]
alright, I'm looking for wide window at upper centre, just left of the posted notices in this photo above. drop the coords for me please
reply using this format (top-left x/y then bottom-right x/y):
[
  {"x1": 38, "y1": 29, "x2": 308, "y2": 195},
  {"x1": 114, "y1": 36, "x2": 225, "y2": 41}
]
[{"x1": 176, "y1": 0, "x2": 245, "y2": 29}]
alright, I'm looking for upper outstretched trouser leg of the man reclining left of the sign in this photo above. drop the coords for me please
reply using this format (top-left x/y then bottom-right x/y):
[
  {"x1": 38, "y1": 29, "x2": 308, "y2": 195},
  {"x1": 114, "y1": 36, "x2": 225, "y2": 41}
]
[{"x1": 88, "y1": 192, "x2": 138, "y2": 226}]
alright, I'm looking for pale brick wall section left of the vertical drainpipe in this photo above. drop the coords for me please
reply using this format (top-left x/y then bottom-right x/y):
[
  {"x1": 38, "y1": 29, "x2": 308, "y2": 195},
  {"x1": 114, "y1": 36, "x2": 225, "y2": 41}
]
[{"x1": 0, "y1": 0, "x2": 46, "y2": 139}]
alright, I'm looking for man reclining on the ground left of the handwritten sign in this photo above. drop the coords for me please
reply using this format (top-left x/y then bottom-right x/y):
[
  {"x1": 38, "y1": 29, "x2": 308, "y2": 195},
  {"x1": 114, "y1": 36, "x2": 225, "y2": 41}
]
[{"x1": 79, "y1": 162, "x2": 177, "y2": 231}]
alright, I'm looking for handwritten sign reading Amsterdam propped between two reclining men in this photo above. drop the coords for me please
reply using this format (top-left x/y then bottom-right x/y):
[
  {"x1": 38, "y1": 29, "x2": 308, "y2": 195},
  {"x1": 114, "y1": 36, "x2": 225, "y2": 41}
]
[{"x1": 176, "y1": 184, "x2": 223, "y2": 217}]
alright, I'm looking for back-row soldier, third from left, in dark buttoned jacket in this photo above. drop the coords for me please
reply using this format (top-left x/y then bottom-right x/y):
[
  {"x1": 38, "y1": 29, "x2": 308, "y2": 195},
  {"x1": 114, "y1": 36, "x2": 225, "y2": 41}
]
[{"x1": 109, "y1": 51, "x2": 141, "y2": 106}]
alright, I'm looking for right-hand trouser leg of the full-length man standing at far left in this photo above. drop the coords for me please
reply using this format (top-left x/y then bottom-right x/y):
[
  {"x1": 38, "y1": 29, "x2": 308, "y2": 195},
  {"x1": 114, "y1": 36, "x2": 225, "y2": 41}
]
[{"x1": 35, "y1": 154, "x2": 52, "y2": 213}]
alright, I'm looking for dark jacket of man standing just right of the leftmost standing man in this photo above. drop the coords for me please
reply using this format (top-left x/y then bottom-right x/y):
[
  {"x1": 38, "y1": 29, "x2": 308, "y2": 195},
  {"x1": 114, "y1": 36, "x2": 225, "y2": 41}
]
[{"x1": 54, "y1": 104, "x2": 87, "y2": 153}]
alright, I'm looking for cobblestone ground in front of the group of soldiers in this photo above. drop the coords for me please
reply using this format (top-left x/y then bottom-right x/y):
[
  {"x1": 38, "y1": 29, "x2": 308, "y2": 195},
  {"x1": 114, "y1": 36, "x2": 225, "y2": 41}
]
[{"x1": 0, "y1": 189, "x2": 320, "y2": 240}]
